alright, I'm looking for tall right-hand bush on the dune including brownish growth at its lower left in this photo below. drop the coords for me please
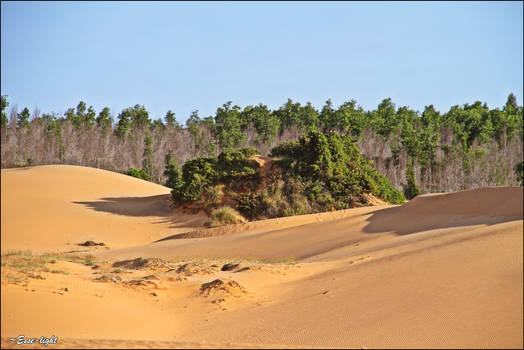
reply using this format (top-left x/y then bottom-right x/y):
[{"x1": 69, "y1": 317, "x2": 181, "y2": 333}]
[{"x1": 225, "y1": 131, "x2": 405, "y2": 219}]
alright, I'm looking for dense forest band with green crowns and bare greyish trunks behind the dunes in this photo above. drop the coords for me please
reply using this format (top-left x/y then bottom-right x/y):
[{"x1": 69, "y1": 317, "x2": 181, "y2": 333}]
[{"x1": 1, "y1": 94, "x2": 523, "y2": 197}]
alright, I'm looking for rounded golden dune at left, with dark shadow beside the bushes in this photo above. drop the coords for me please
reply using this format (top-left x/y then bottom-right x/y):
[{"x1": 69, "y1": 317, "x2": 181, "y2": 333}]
[{"x1": 1, "y1": 165, "x2": 205, "y2": 251}]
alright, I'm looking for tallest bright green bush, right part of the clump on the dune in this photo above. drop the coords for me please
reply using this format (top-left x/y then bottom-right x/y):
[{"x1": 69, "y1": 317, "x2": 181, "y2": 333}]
[{"x1": 271, "y1": 131, "x2": 404, "y2": 210}]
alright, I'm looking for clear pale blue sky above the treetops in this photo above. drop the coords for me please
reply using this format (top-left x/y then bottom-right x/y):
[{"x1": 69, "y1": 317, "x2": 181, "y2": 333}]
[{"x1": 1, "y1": 1, "x2": 523, "y2": 122}]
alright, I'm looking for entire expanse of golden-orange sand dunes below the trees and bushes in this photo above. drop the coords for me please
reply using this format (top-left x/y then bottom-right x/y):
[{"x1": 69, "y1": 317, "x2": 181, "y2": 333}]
[{"x1": 2, "y1": 167, "x2": 523, "y2": 348}]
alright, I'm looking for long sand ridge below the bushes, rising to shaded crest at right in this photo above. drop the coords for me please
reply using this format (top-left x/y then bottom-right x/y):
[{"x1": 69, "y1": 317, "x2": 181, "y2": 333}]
[{"x1": 98, "y1": 187, "x2": 522, "y2": 259}]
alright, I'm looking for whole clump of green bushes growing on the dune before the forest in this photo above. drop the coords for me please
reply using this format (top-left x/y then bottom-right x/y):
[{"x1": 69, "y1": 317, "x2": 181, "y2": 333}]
[{"x1": 166, "y1": 131, "x2": 405, "y2": 220}]
